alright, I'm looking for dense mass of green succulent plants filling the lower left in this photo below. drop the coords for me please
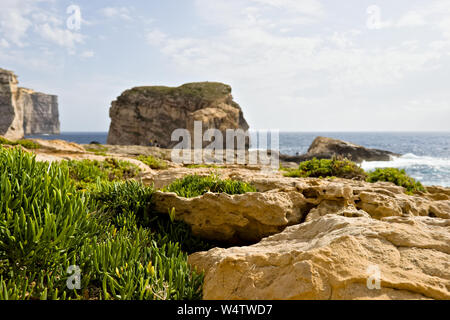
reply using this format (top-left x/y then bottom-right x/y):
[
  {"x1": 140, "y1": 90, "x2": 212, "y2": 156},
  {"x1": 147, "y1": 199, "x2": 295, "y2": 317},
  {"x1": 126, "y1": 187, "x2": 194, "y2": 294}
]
[{"x1": 0, "y1": 147, "x2": 208, "y2": 300}]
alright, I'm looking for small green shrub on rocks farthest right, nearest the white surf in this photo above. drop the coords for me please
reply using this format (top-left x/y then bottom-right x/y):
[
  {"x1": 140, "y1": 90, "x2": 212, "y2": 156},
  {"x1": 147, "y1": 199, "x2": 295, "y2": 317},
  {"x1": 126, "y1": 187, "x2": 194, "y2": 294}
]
[{"x1": 367, "y1": 168, "x2": 425, "y2": 194}]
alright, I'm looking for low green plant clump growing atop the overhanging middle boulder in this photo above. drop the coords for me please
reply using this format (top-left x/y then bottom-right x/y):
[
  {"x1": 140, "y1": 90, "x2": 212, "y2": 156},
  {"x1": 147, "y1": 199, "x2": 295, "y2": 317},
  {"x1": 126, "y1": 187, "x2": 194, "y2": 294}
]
[{"x1": 163, "y1": 175, "x2": 257, "y2": 198}]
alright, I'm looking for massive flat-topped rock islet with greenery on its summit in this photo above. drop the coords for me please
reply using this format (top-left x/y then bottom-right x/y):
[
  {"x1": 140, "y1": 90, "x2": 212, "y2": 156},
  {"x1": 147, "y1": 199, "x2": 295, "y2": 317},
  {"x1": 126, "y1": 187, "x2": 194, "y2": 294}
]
[{"x1": 108, "y1": 82, "x2": 248, "y2": 148}]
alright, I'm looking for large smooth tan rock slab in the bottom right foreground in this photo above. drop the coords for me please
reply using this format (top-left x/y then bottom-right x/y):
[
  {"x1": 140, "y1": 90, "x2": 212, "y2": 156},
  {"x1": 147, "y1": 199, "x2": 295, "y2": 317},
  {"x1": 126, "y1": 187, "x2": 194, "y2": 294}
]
[{"x1": 189, "y1": 215, "x2": 450, "y2": 300}]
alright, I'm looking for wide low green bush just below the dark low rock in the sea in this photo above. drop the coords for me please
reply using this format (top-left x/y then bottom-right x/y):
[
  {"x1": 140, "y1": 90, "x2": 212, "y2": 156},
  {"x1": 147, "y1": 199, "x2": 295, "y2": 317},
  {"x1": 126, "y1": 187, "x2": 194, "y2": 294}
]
[{"x1": 283, "y1": 158, "x2": 367, "y2": 180}]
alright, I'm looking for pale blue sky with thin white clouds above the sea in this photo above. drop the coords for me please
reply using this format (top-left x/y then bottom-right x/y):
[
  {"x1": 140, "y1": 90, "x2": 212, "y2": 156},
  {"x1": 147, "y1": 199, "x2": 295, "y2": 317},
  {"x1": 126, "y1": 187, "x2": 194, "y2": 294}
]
[{"x1": 0, "y1": 0, "x2": 450, "y2": 131}]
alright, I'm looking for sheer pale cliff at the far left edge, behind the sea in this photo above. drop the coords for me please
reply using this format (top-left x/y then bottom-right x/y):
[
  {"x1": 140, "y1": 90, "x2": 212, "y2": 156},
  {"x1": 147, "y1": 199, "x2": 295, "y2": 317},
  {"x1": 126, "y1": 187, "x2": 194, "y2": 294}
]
[{"x1": 0, "y1": 69, "x2": 60, "y2": 140}]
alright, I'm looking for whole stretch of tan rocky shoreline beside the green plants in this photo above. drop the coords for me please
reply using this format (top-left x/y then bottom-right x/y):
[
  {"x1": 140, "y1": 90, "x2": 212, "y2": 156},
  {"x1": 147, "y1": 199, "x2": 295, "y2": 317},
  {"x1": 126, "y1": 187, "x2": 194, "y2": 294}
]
[{"x1": 0, "y1": 141, "x2": 450, "y2": 300}]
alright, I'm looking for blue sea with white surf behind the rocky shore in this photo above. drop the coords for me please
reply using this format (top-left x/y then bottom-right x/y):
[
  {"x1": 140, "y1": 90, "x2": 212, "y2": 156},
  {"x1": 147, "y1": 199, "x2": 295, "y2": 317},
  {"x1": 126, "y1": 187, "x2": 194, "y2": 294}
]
[{"x1": 27, "y1": 132, "x2": 450, "y2": 187}]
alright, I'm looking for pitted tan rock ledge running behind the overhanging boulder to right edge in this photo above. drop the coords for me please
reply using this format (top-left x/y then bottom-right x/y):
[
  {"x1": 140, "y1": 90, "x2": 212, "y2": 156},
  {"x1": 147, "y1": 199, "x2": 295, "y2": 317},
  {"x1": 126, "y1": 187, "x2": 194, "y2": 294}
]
[{"x1": 149, "y1": 168, "x2": 450, "y2": 221}]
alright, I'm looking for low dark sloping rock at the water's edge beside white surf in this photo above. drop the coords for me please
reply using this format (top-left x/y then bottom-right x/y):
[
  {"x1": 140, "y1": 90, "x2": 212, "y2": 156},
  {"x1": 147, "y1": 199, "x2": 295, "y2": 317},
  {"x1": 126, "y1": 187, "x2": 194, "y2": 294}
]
[{"x1": 281, "y1": 137, "x2": 400, "y2": 163}]
